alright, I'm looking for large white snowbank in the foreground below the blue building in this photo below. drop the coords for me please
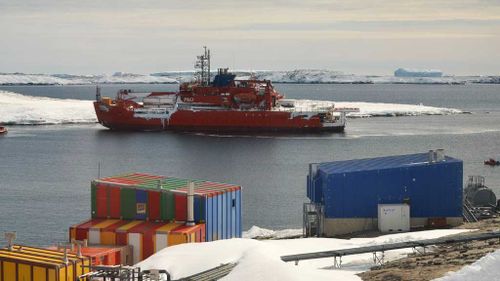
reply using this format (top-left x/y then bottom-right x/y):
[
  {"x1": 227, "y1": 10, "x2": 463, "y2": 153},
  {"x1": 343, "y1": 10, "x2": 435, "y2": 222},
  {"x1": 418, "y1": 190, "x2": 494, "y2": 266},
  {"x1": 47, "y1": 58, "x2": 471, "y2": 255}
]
[{"x1": 137, "y1": 228, "x2": 468, "y2": 281}]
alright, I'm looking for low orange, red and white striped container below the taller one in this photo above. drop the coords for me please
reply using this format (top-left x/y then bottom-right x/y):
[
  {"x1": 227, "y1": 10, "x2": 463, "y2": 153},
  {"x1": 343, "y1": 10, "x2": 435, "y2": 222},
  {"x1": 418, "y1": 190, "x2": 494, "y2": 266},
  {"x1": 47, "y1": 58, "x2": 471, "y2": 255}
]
[{"x1": 70, "y1": 219, "x2": 206, "y2": 264}]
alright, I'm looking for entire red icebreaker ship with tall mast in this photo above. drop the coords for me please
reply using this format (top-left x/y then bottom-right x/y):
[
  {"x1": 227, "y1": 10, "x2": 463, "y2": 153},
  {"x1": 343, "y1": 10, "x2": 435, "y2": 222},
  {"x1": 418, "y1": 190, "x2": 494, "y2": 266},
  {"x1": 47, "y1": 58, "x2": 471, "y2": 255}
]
[{"x1": 94, "y1": 48, "x2": 357, "y2": 133}]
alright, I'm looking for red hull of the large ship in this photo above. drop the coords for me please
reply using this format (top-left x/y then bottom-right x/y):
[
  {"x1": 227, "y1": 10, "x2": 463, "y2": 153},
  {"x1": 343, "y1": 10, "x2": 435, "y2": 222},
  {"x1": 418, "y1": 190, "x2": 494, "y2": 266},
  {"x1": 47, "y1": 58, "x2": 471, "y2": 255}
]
[{"x1": 94, "y1": 102, "x2": 344, "y2": 132}]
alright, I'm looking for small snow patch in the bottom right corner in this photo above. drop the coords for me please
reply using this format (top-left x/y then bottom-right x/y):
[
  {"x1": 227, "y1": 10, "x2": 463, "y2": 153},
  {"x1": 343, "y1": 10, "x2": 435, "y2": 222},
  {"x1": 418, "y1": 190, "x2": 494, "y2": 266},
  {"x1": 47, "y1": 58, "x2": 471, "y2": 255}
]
[{"x1": 434, "y1": 247, "x2": 500, "y2": 281}]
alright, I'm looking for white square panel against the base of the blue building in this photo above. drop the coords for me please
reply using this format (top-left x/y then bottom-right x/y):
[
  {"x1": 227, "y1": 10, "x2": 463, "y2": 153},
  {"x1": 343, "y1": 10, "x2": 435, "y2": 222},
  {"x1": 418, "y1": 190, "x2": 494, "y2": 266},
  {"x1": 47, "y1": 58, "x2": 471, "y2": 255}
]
[{"x1": 378, "y1": 204, "x2": 410, "y2": 232}]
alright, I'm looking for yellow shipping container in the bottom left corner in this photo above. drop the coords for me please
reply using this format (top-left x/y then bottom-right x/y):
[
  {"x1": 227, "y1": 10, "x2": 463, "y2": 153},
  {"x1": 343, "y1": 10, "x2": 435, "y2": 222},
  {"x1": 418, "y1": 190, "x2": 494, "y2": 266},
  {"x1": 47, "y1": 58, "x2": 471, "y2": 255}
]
[{"x1": 0, "y1": 245, "x2": 90, "y2": 281}]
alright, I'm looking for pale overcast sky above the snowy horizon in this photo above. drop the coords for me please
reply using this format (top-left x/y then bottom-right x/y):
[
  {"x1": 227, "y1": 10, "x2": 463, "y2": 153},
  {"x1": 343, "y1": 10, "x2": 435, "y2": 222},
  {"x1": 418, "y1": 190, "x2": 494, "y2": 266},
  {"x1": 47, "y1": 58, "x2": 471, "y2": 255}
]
[{"x1": 0, "y1": 0, "x2": 500, "y2": 75}]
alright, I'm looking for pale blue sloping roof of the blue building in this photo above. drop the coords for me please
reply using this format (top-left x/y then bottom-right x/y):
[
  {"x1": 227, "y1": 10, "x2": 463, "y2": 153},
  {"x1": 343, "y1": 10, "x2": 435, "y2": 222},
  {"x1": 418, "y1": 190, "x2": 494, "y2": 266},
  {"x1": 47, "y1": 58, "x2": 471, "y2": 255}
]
[{"x1": 318, "y1": 153, "x2": 462, "y2": 174}]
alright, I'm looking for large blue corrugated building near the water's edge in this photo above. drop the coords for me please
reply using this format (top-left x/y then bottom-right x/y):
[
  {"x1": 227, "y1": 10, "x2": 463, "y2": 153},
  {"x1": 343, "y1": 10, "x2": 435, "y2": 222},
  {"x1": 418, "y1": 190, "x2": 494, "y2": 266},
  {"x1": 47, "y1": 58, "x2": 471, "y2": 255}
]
[{"x1": 307, "y1": 150, "x2": 463, "y2": 236}]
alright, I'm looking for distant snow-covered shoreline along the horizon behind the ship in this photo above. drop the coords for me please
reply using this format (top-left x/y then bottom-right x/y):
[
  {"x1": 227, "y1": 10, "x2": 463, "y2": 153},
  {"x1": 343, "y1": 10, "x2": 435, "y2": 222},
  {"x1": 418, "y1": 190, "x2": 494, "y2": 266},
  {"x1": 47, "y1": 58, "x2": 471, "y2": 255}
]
[{"x1": 0, "y1": 69, "x2": 500, "y2": 85}]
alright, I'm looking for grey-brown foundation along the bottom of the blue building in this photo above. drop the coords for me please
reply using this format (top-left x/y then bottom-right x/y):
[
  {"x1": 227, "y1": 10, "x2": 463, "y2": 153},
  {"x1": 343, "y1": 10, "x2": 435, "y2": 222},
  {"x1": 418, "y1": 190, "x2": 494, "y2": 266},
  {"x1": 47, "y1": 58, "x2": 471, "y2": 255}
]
[{"x1": 323, "y1": 217, "x2": 463, "y2": 237}]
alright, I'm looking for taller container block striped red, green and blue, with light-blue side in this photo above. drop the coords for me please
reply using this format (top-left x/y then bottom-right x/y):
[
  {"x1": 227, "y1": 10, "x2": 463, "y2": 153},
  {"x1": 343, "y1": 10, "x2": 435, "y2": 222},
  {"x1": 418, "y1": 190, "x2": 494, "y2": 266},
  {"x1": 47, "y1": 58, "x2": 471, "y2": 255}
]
[{"x1": 92, "y1": 173, "x2": 242, "y2": 241}]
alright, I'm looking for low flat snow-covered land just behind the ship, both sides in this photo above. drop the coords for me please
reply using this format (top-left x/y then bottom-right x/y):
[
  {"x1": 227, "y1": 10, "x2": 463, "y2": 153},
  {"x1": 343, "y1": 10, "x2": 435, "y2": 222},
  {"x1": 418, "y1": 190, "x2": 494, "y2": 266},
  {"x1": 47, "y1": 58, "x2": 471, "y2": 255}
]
[{"x1": 0, "y1": 91, "x2": 463, "y2": 125}]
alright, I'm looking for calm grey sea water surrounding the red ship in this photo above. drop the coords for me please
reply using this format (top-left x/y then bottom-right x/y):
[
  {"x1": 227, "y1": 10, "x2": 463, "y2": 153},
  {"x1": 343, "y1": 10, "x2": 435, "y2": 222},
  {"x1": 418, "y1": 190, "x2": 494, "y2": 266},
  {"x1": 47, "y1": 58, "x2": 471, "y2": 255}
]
[{"x1": 0, "y1": 84, "x2": 500, "y2": 246}]
